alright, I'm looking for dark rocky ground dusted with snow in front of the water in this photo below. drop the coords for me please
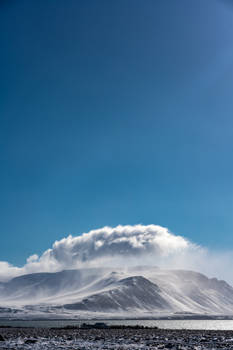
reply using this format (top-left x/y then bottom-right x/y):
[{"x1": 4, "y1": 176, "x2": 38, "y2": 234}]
[{"x1": 0, "y1": 328, "x2": 233, "y2": 350}]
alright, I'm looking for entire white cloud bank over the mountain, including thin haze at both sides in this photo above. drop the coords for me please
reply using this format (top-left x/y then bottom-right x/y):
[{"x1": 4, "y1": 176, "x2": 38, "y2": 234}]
[{"x1": 0, "y1": 225, "x2": 230, "y2": 281}]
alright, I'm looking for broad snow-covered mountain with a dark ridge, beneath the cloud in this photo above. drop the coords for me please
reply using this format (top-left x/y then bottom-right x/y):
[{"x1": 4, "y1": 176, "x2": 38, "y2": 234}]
[{"x1": 0, "y1": 267, "x2": 233, "y2": 316}]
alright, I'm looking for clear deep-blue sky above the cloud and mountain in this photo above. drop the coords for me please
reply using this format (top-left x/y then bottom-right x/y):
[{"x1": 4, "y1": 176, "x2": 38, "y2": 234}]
[{"x1": 0, "y1": 0, "x2": 233, "y2": 264}]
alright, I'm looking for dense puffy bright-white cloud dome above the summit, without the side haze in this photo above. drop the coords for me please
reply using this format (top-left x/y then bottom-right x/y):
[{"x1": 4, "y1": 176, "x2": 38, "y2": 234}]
[{"x1": 45, "y1": 225, "x2": 191, "y2": 266}]
